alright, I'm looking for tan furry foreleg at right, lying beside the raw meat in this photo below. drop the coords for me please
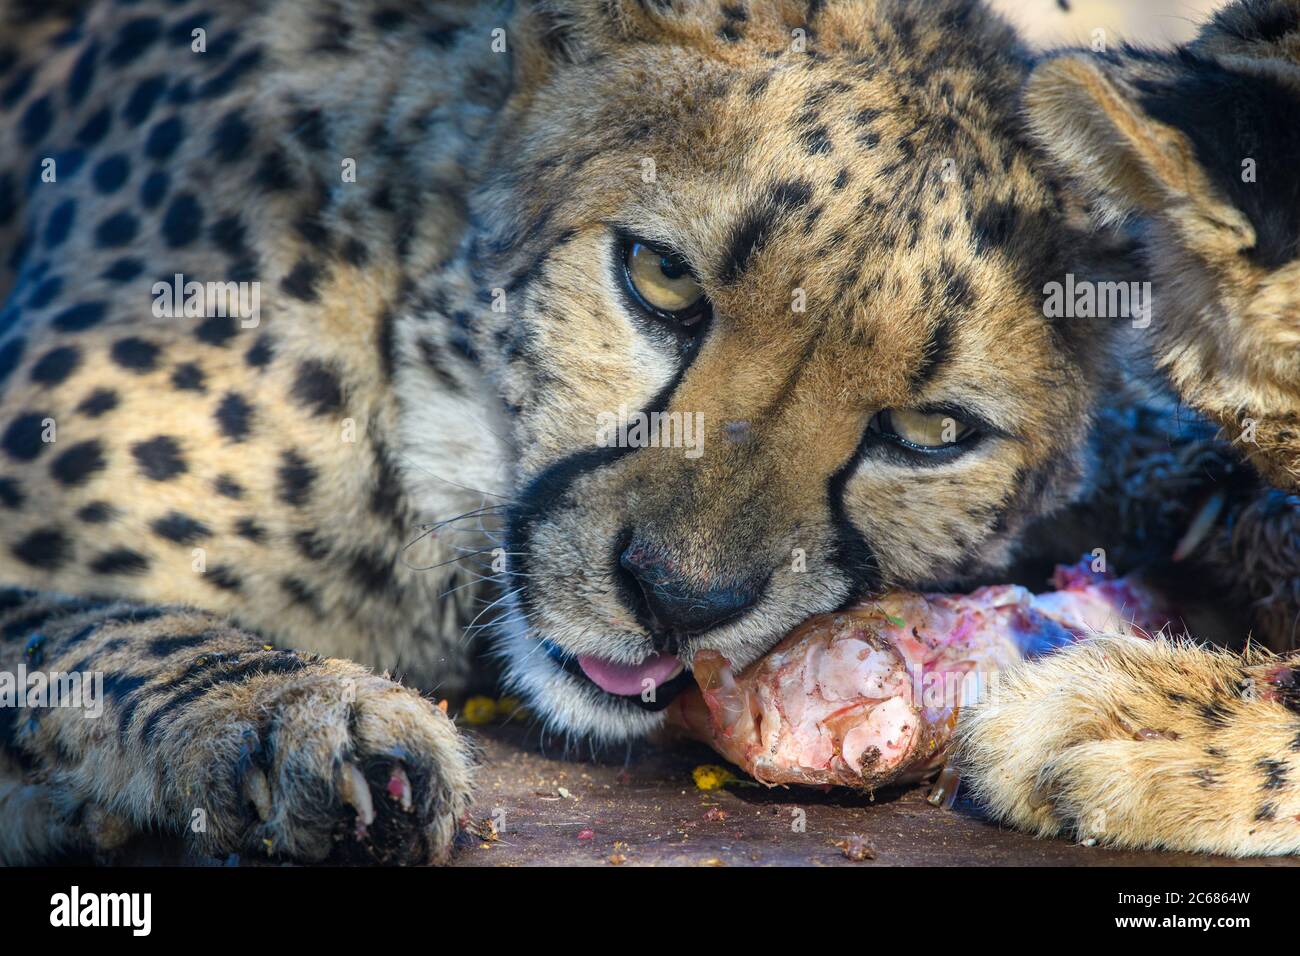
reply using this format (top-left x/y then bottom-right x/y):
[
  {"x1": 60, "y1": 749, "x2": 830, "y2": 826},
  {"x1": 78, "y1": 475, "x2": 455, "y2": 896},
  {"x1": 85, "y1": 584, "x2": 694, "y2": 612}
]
[{"x1": 957, "y1": 636, "x2": 1300, "y2": 856}]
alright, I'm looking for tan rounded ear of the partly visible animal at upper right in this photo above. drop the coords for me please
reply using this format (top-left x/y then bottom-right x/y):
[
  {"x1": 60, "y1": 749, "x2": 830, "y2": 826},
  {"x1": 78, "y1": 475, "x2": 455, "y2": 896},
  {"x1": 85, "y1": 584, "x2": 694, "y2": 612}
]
[{"x1": 1024, "y1": 53, "x2": 1256, "y2": 255}]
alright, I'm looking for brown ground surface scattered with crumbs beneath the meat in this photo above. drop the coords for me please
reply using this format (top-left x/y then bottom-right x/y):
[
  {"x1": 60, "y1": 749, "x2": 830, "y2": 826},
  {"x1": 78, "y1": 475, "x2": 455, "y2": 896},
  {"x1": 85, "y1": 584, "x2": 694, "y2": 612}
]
[{"x1": 455, "y1": 726, "x2": 1300, "y2": 866}]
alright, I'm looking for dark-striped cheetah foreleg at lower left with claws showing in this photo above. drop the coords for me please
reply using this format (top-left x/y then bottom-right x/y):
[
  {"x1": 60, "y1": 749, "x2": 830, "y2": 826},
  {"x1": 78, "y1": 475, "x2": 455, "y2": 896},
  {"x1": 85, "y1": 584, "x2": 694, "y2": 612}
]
[{"x1": 0, "y1": 591, "x2": 473, "y2": 862}]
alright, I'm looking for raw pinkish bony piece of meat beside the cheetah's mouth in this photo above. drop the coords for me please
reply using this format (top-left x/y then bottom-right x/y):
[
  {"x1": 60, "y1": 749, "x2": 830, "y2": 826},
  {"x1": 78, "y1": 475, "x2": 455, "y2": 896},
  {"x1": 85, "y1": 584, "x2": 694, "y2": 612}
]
[{"x1": 668, "y1": 561, "x2": 1171, "y2": 788}]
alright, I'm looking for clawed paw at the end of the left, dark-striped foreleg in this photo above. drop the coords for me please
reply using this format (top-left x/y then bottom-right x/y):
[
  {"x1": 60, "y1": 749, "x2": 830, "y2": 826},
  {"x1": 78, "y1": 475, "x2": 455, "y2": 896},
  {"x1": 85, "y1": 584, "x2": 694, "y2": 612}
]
[{"x1": 164, "y1": 652, "x2": 473, "y2": 864}]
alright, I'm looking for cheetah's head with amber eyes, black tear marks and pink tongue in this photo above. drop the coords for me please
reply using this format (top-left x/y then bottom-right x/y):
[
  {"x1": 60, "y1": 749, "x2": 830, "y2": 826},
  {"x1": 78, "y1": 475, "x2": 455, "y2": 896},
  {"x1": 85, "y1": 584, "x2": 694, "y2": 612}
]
[{"x1": 460, "y1": 0, "x2": 1106, "y2": 741}]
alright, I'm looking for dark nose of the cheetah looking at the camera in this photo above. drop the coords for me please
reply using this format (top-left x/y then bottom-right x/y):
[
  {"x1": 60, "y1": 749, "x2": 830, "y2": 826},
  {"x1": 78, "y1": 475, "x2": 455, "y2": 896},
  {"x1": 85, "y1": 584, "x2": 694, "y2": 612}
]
[{"x1": 619, "y1": 541, "x2": 759, "y2": 654}]
